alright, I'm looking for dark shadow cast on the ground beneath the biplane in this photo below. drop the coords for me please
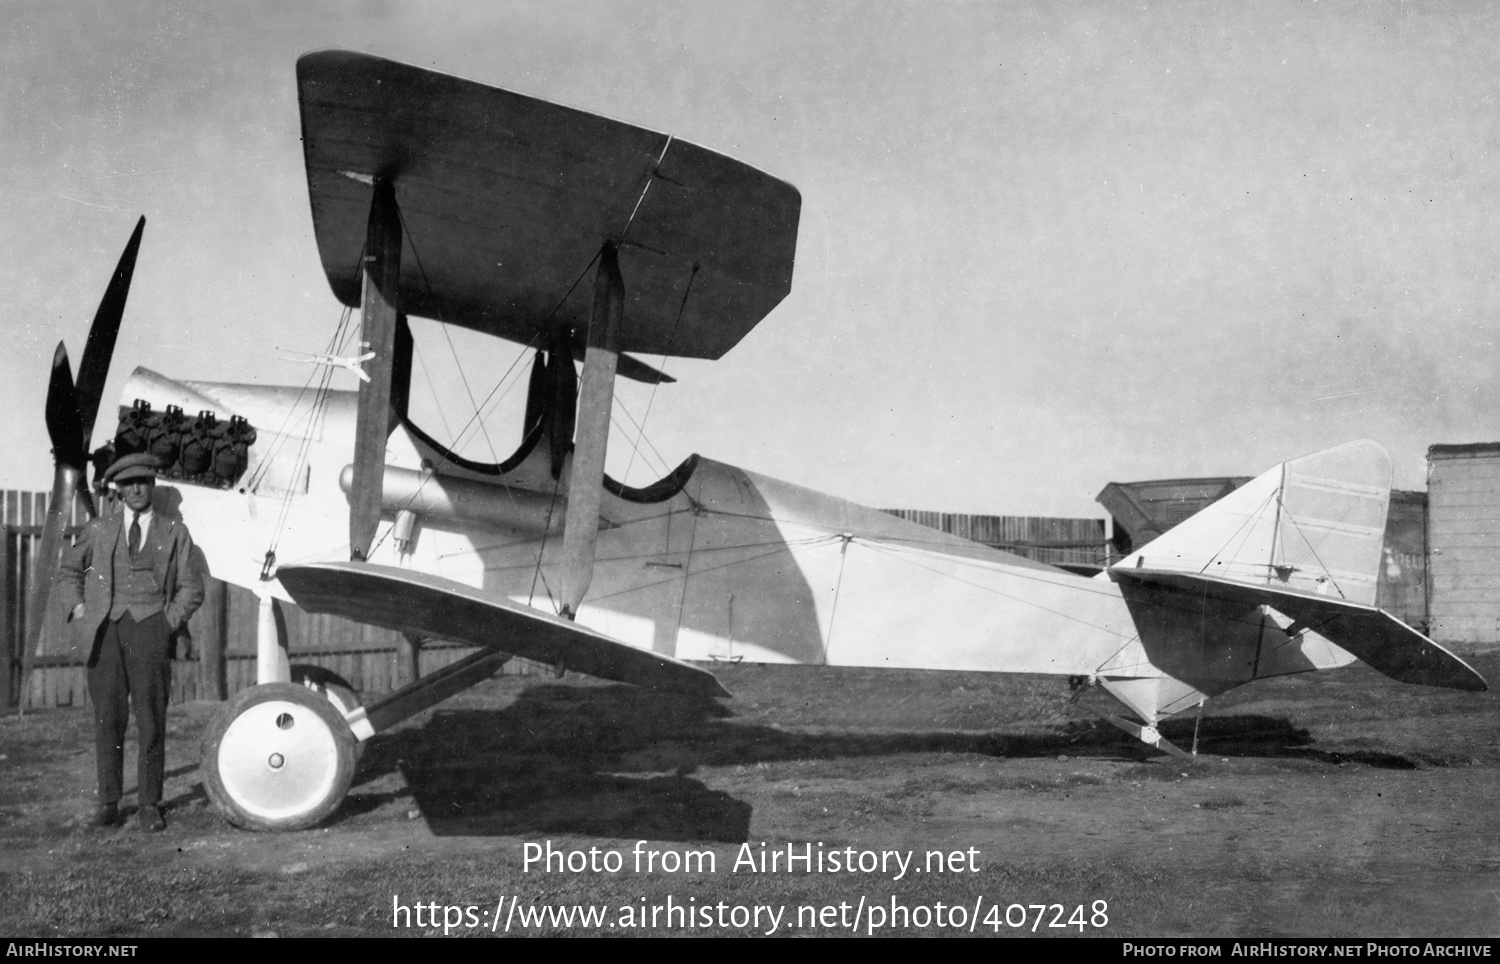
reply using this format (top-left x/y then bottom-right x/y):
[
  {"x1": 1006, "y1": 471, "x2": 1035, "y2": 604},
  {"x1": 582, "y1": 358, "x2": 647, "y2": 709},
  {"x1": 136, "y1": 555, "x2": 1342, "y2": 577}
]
[{"x1": 331, "y1": 685, "x2": 1415, "y2": 843}]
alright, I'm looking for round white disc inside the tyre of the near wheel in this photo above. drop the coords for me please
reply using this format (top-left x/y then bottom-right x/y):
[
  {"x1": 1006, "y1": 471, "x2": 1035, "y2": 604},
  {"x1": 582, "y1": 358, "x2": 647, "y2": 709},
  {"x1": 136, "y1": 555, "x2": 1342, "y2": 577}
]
[{"x1": 218, "y1": 700, "x2": 339, "y2": 820}]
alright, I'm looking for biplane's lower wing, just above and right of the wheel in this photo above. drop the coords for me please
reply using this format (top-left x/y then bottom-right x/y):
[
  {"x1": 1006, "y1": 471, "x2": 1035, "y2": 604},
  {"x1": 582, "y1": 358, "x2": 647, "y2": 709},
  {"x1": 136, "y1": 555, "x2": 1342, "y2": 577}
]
[{"x1": 276, "y1": 562, "x2": 729, "y2": 696}]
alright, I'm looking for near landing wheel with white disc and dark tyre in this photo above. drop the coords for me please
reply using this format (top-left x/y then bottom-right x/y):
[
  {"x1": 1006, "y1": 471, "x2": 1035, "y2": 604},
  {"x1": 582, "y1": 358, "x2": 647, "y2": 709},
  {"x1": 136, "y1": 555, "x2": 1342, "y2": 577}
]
[{"x1": 200, "y1": 682, "x2": 356, "y2": 831}]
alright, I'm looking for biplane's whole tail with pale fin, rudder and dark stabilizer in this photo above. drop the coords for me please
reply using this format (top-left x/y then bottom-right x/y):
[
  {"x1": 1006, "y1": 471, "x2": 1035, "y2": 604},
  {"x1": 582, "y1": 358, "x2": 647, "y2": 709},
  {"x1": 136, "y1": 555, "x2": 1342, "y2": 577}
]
[{"x1": 1097, "y1": 441, "x2": 1487, "y2": 755}]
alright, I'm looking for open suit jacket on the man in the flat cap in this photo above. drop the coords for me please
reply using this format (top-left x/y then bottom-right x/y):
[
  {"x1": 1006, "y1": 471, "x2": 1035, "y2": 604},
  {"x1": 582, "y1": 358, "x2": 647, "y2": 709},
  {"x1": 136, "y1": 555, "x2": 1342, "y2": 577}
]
[{"x1": 57, "y1": 511, "x2": 203, "y2": 666}]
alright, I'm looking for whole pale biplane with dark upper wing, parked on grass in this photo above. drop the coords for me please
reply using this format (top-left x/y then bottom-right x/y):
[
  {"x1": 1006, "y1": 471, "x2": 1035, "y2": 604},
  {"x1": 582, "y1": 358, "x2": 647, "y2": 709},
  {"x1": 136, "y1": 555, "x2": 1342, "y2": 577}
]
[{"x1": 33, "y1": 51, "x2": 1485, "y2": 831}]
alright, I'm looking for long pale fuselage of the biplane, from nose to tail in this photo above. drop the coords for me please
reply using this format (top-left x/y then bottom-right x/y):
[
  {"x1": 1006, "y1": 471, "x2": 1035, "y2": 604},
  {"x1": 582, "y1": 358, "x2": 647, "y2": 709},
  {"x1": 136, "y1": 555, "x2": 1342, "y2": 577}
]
[{"x1": 105, "y1": 370, "x2": 1350, "y2": 714}]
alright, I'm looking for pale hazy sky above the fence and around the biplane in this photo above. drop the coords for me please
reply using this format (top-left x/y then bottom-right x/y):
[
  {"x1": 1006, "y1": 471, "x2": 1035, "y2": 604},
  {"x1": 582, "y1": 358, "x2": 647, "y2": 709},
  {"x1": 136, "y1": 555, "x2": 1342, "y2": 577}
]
[{"x1": 0, "y1": 0, "x2": 1500, "y2": 516}]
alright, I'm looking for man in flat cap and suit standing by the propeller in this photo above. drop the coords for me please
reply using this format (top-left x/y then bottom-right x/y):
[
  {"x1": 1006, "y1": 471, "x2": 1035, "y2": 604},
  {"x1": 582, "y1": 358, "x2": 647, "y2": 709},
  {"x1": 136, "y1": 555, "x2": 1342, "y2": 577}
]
[{"x1": 57, "y1": 453, "x2": 203, "y2": 832}]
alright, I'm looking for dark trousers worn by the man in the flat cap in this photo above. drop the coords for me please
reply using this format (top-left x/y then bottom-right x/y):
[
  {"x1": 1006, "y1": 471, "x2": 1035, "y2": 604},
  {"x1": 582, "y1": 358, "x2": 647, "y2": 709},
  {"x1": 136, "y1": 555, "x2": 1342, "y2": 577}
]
[{"x1": 89, "y1": 613, "x2": 173, "y2": 807}]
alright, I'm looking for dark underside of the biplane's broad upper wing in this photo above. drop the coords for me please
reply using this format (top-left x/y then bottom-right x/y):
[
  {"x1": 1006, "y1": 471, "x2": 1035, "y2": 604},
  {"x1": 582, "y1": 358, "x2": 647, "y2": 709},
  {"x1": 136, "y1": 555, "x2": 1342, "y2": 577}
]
[{"x1": 297, "y1": 51, "x2": 801, "y2": 358}]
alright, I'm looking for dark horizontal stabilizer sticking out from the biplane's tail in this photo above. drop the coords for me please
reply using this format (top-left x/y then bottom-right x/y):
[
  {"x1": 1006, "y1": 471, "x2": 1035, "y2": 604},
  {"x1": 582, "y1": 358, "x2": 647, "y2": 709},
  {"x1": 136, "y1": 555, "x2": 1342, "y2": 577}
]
[{"x1": 1110, "y1": 568, "x2": 1488, "y2": 691}]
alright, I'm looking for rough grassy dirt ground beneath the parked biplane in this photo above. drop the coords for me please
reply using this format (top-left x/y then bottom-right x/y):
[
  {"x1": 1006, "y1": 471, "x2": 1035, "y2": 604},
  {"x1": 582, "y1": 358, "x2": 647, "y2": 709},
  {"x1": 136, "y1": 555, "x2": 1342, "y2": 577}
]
[{"x1": 0, "y1": 657, "x2": 1500, "y2": 937}]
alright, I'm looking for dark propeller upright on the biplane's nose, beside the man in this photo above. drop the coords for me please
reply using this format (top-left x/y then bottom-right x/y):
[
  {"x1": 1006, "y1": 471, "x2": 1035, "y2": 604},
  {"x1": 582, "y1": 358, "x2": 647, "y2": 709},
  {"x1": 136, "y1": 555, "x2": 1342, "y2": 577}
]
[{"x1": 21, "y1": 217, "x2": 146, "y2": 705}]
